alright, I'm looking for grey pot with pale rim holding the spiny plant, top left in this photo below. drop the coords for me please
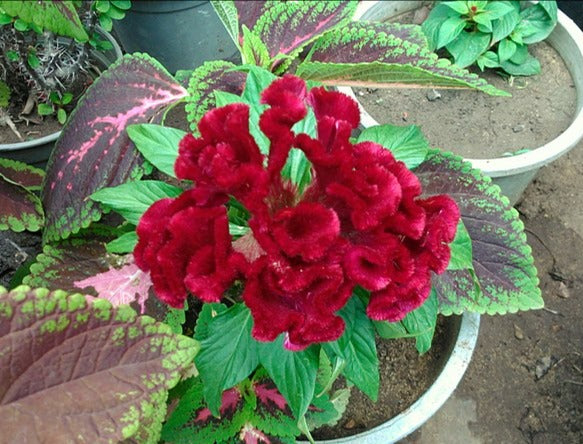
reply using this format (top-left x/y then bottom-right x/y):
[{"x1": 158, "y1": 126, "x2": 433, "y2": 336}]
[{"x1": 0, "y1": 29, "x2": 122, "y2": 168}]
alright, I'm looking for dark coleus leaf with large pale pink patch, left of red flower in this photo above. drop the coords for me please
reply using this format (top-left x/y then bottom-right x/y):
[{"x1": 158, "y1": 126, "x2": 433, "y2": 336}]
[{"x1": 24, "y1": 238, "x2": 176, "y2": 321}]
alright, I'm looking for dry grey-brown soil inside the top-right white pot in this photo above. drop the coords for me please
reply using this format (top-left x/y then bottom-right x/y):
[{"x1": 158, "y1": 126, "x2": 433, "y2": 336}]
[{"x1": 355, "y1": 42, "x2": 576, "y2": 159}]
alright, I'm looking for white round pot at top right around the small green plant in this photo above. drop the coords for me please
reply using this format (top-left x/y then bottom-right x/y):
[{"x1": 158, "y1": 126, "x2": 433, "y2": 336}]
[{"x1": 341, "y1": 1, "x2": 583, "y2": 204}]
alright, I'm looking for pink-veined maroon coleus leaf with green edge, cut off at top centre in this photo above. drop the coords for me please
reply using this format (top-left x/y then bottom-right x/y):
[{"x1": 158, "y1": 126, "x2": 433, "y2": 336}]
[{"x1": 223, "y1": 0, "x2": 357, "y2": 70}]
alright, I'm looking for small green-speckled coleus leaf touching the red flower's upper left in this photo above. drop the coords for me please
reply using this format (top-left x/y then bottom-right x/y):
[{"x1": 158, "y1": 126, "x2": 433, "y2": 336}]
[{"x1": 185, "y1": 60, "x2": 248, "y2": 133}]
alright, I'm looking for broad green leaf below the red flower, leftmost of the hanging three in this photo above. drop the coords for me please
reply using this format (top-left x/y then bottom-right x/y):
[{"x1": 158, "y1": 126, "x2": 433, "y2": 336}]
[{"x1": 195, "y1": 304, "x2": 258, "y2": 416}]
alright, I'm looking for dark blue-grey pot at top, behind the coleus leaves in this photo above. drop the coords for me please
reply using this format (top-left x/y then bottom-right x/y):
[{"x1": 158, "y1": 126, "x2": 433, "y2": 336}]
[{"x1": 113, "y1": 0, "x2": 238, "y2": 73}]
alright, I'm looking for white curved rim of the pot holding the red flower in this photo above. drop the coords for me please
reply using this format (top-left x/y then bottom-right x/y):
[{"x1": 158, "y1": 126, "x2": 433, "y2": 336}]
[{"x1": 300, "y1": 313, "x2": 480, "y2": 444}]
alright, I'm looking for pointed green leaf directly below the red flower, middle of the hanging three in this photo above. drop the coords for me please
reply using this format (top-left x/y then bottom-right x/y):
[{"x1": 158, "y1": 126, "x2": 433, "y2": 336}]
[{"x1": 257, "y1": 335, "x2": 320, "y2": 419}]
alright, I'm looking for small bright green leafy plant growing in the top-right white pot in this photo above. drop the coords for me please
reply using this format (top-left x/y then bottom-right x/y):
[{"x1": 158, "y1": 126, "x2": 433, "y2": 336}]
[{"x1": 422, "y1": 0, "x2": 557, "y2": 76}]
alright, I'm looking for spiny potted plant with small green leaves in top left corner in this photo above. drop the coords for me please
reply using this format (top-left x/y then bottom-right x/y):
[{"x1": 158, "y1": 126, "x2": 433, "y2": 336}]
[{"x1": 0, "y1": 1, "x2": 129, "y2": 165}]
